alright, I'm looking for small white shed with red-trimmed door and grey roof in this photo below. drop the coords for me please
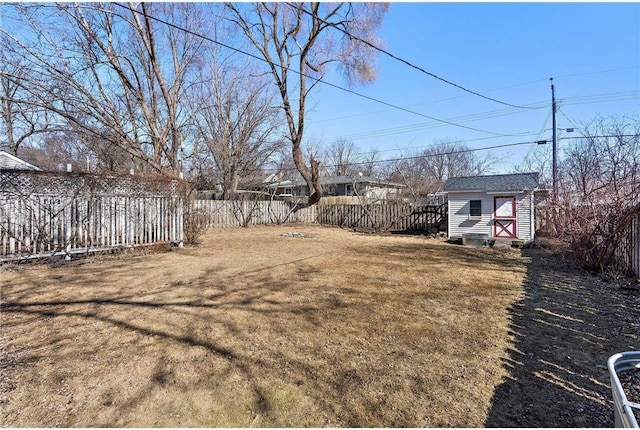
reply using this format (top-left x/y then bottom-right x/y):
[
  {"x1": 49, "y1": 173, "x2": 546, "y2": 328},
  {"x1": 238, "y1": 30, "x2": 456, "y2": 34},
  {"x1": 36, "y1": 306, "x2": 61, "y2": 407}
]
[{"x1": 444, "y1": 173, "x2": 539, "y2": 242}]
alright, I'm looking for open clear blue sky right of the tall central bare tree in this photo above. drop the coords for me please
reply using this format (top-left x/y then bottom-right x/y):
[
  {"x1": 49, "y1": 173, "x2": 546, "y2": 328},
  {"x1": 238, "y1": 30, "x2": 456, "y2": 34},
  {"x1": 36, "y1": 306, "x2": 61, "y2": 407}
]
[{"x1": 307, "y1": 3, "x2": 640, "y2": 173}]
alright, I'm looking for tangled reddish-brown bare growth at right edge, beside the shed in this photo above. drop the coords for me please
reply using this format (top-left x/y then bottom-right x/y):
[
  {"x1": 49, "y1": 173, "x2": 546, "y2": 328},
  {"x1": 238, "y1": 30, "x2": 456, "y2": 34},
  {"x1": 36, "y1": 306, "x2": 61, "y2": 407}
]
[{"x1": 555, "y1": 117, "x2": 640, "y2": 272}]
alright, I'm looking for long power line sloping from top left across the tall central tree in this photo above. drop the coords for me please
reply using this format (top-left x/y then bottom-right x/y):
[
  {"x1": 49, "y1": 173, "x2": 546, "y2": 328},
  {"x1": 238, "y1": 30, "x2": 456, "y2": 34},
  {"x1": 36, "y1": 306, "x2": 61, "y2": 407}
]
[{"x1": 113, "y1": 3, "x2": 510, "y2": 137}]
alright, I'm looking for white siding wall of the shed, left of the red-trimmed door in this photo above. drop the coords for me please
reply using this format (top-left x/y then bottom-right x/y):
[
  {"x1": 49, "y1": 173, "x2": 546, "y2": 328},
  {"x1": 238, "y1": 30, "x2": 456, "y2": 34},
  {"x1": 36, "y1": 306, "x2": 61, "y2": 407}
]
[{"x1": 449, "y1": 193, "x2": 493, "y2": 237}]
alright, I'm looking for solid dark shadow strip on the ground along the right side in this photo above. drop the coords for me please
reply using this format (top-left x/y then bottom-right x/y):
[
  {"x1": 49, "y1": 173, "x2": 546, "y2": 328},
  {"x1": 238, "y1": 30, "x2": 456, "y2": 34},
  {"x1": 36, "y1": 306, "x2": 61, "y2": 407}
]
[{"x1": 486, "y1": 245, "x2": 637, "y2": 427}]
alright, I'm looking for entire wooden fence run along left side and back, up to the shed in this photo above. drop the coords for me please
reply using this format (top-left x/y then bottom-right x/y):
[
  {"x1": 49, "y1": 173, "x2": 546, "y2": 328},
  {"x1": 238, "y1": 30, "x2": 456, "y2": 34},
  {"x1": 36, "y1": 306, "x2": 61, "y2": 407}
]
[{"x1": 0, "y1": 170, "x2": 447, "y2": 262}]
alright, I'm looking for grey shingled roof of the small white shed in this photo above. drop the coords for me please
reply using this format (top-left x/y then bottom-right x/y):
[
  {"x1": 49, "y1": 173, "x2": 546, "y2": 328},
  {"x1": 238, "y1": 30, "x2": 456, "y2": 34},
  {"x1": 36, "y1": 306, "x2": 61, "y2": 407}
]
[{"x1": 444, "y1": 172, "x2": 539, "y2": 192}]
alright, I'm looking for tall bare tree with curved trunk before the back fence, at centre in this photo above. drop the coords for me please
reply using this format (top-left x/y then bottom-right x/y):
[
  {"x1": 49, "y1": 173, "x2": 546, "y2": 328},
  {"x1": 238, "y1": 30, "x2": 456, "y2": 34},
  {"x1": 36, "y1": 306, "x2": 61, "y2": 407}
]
[{"x1": 227, "y1": 3, "x2": 388, "y2": 205}]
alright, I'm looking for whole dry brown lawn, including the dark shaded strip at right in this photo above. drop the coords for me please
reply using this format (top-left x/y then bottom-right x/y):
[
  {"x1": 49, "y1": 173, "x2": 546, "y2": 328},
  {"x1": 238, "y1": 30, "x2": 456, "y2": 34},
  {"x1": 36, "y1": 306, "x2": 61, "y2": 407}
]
[{"x1": 0, "y1": 226, "x2": 638, "y2": 427}]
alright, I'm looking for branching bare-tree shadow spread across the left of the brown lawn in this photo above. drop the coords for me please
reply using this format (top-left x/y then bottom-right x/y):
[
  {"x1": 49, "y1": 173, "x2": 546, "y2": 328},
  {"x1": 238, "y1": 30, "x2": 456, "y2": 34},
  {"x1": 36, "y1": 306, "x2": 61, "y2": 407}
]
[{"x1": 0, "y1": 252, "x2": 384, "y2": 427}]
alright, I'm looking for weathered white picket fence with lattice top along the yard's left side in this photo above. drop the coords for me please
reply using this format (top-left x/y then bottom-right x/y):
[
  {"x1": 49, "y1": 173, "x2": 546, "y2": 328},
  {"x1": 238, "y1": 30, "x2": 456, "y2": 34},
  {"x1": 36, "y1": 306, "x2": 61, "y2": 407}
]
[{"x1": 0, "y1": 170, "x2": 184, "y2": 261}]
